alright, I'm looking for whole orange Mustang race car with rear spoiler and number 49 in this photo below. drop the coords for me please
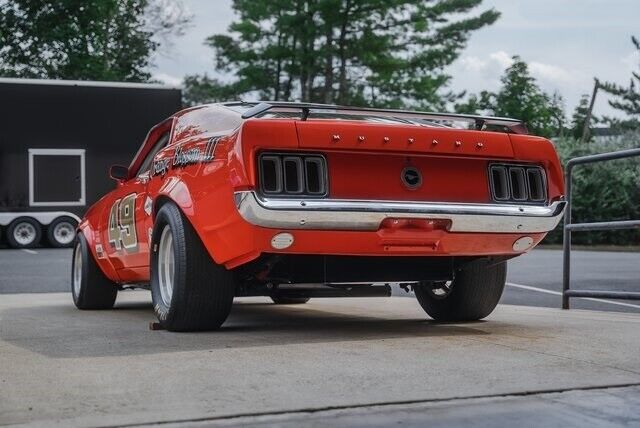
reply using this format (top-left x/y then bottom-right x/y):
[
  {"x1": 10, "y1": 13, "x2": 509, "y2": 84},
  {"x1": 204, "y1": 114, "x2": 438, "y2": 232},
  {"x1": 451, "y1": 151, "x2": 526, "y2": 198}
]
[{"x1": 72, "y1": 102, "x2": 565, "y2": 331}]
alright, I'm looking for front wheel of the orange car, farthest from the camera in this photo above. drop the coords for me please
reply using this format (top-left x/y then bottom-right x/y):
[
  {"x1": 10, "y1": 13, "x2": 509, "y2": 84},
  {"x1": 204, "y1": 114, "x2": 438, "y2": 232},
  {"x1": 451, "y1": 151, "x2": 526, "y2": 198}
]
[{"x1": 71, "y1": 232, "x2": 118, "y2": 309}]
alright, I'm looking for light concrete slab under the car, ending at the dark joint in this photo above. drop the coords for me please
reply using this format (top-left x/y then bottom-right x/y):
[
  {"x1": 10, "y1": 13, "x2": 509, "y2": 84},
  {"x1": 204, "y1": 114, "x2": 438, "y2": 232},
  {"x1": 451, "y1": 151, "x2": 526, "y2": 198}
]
[{"x1": 0, "y1": 292, "x2": 640, "y2": 426}]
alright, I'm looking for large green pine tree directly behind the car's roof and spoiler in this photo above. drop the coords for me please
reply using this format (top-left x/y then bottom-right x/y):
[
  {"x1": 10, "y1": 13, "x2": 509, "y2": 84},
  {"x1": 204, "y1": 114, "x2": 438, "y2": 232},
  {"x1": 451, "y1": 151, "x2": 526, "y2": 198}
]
[{"x1": 186, "y1": 0, "x2": 499, "y2": 109}]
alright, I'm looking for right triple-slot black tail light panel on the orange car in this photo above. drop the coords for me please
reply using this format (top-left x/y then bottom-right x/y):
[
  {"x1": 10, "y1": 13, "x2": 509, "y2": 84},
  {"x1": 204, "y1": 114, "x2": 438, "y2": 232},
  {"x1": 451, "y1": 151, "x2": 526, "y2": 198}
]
[{"x1": 489, "y1": 164, "x2": 547, "y2": 203}]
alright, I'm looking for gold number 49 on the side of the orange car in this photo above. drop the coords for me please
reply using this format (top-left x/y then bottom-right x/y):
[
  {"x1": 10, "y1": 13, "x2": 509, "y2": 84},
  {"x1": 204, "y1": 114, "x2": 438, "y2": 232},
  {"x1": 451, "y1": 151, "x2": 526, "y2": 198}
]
[{"x1": 109, "y1": 193, "x2": 138, "y2": 253}]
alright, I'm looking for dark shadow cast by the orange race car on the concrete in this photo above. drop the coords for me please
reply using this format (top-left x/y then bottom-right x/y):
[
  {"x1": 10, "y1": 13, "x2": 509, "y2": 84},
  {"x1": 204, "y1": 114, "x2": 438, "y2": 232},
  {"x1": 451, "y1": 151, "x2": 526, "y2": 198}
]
[{"x1": 0, "y1": 302, "x2": 500, "y2": 358}]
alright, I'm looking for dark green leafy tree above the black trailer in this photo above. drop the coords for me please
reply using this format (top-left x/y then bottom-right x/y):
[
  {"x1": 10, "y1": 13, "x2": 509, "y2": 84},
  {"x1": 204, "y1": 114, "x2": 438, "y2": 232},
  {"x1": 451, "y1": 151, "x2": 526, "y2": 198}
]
[{"x1": 0, "y1": 0, "x2": 190, "y2": 81}]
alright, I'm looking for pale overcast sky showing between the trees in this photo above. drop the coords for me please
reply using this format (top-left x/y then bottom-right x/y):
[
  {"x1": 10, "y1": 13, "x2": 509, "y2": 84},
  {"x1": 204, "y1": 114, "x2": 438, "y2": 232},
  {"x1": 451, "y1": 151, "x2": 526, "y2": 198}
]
[{"x1": 153, "y1": 0, "x2": 640, "y2": 115}]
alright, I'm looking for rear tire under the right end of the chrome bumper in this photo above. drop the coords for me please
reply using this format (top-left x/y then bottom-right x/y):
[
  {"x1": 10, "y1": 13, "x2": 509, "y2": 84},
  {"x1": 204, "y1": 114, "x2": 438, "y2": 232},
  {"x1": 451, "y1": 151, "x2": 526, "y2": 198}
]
[{"x1": 414, "y1": 260, "x2": 507, "y2": 321}]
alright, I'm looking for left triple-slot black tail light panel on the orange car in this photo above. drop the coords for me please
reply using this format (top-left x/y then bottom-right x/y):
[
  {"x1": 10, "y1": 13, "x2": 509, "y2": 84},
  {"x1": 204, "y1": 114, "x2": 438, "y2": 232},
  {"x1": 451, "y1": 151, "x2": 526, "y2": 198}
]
[{"x1": 258, "y1": 153, "x2": 329, "y2": 197}]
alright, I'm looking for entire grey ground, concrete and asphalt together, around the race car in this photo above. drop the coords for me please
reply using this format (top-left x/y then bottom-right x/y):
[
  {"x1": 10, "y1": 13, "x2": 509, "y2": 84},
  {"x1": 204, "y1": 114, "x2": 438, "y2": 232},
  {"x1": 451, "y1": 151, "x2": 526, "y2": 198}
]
[{"x1": 0, "y1": 249, "x2": 640, "y2": 427}]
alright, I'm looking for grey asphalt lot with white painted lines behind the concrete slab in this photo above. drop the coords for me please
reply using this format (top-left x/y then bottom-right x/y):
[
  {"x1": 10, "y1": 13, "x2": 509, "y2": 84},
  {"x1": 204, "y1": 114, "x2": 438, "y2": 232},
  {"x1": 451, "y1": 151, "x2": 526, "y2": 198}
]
[{"x1": 0, "y1": 249, "x2": 640, "y2": 312}]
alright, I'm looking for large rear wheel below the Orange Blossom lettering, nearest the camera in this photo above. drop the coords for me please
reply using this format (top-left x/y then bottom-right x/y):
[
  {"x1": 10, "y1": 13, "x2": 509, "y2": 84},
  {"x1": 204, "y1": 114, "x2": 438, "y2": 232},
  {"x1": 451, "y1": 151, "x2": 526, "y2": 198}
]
[{"x1": 150, "y1": 202, "x2": 236, "y2": 331}]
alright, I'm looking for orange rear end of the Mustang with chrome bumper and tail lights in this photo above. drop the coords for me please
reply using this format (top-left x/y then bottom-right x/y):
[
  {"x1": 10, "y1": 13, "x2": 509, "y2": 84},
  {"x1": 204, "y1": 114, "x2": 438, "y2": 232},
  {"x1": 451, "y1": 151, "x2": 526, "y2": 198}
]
[{"x1": 226, "y1": 106, "x2": 564, "y2": 276}]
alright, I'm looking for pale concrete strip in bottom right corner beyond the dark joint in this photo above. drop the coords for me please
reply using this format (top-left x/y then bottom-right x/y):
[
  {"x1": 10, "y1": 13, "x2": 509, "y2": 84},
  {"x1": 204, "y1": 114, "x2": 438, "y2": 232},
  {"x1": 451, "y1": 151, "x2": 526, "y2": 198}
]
[{"x1": 186, "y1": 386, "x2": 640, "y2": 428}]
